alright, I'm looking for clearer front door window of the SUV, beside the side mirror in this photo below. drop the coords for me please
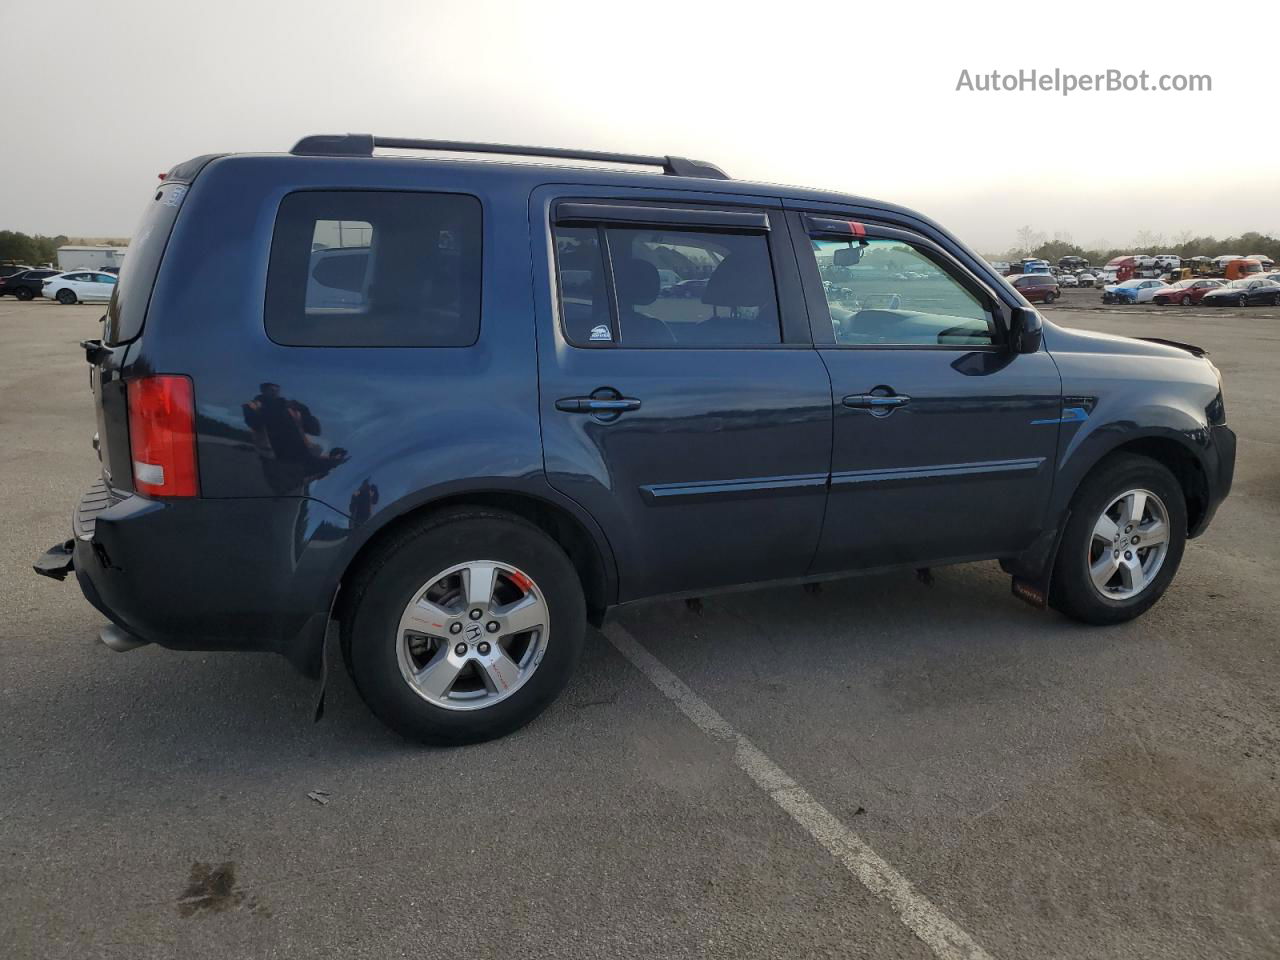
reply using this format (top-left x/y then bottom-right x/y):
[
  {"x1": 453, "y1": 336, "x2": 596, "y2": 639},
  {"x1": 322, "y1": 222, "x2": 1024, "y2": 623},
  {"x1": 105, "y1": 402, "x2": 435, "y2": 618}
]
[{"x1": 810, "y1": 238, "x2": 998, "y2": 347}]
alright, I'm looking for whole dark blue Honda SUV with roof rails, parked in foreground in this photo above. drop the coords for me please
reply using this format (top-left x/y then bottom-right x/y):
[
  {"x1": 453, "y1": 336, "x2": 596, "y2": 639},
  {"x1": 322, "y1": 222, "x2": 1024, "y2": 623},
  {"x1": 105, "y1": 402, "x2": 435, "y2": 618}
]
[{"x1": 37, "y1": 136, "x2": 1235, "y2": 742}]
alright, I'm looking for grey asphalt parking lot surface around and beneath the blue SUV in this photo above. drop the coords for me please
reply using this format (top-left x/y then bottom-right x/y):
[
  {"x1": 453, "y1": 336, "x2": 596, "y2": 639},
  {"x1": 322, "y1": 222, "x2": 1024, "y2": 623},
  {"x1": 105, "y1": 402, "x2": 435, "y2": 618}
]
[{"x1": 0, "y1": 291, "x2": 1280, "y2": 960}]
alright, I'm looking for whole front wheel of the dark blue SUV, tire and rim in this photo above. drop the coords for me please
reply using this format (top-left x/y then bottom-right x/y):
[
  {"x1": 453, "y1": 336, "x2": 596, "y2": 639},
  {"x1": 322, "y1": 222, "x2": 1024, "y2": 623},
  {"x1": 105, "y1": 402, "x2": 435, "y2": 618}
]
[{"x1": 1050, "y1": 454, "x2": 1187, "y2": 625}]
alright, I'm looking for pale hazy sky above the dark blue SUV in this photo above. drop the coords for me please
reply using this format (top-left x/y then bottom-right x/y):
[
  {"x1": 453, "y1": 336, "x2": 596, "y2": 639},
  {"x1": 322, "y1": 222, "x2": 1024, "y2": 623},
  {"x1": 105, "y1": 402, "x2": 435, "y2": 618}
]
[{"x1": 0, "y1": 0, "x2": 1280, "y2": 253}]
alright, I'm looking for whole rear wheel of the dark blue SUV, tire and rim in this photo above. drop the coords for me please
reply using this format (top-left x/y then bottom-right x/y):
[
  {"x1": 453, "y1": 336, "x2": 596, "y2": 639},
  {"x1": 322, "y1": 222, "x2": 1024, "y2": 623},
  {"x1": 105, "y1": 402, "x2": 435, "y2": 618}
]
[{"x1": 343, "y1": 509, "x2": 586, "y2": 745}]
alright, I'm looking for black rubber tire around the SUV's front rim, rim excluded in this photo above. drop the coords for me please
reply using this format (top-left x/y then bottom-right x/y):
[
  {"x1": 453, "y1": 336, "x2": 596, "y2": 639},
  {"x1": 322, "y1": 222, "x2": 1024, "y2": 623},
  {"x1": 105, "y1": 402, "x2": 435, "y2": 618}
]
[{"x1": 1050, "y1": 453, "x2": 1187, "y2": 626}]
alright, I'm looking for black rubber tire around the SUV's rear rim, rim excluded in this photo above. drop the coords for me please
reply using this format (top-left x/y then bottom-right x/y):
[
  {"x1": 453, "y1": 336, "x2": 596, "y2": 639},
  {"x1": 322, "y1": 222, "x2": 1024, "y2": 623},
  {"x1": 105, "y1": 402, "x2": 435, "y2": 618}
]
[{"x1": 342, "y1": 508, "x2": 586, "y2": 745}]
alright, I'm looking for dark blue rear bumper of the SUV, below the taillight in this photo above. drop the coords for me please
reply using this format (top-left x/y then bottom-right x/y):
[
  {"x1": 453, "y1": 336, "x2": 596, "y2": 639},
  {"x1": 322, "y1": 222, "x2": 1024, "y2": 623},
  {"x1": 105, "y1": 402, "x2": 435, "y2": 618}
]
[{"x1": 37, "y1": 484, "x2": 348, "y2": 676}]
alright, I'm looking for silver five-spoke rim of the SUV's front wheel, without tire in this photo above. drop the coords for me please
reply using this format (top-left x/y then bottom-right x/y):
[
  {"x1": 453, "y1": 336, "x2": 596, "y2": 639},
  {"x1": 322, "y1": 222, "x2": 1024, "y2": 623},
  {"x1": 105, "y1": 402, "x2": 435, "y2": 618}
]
[{"x1": 1087, "y1": 490, "x2": 1169, "y2": 600}]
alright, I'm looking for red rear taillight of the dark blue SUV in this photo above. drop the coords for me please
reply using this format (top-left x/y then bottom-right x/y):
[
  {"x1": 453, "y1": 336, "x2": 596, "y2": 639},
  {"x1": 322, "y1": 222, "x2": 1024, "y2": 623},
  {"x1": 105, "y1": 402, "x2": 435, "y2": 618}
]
[{"x1": 128, "y1": 375, "x2": 200, "y2": 497}]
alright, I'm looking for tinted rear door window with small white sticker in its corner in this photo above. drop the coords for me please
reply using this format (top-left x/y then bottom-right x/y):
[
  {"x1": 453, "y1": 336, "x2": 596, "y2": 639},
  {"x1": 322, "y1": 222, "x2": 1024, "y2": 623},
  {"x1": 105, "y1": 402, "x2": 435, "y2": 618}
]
[{"x1": 556, "y1": 225, "x2": 782, "y2": 347}]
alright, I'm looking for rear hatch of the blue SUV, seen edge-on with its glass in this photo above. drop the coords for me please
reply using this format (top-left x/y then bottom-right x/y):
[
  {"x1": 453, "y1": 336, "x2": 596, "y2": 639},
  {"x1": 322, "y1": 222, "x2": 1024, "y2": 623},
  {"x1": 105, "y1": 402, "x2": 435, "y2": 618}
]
[{"x1": 82, "y1": 179, "x2": 188, "y2": 499}]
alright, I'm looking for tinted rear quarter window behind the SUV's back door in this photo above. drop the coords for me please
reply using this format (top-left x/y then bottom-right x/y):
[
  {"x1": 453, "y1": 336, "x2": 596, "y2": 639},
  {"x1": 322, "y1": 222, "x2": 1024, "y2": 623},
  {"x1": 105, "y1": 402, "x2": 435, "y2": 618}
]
[{"x1": 266, "y1": 191, "x2": 481, "y2": 347}]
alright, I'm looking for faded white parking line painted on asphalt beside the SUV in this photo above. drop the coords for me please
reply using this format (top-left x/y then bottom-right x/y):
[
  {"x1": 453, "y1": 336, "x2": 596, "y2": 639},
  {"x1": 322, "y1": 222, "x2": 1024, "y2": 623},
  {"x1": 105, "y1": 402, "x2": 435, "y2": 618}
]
[{"x1": 604, "y1": 623, "x2": 991, "y2": 960}]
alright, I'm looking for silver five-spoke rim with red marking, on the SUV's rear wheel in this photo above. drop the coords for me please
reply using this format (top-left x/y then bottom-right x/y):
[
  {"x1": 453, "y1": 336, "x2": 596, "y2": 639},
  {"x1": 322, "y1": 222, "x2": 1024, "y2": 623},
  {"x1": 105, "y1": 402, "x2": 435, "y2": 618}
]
[{"x1": 396, "y1": 561, "x2": 550, "y2": 710}]
